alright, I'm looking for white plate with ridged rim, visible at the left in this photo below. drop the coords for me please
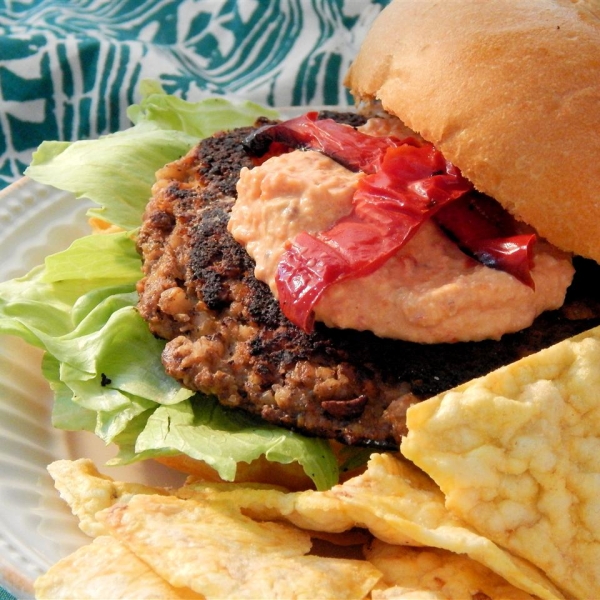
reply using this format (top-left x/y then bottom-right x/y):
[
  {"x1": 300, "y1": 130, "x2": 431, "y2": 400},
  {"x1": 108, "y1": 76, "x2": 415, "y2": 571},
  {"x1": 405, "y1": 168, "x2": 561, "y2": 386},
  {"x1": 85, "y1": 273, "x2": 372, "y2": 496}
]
[{"x1": 0, "y1": 178, "x2": 185, "y2": 599}]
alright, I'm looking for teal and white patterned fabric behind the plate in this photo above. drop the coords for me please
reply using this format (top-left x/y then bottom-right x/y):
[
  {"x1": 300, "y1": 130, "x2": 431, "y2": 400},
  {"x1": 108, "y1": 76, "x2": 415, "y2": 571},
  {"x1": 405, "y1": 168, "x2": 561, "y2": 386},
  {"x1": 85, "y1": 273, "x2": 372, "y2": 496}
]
[{"x1": 0, "y1": 0, "x2": 389, "y2": 188}]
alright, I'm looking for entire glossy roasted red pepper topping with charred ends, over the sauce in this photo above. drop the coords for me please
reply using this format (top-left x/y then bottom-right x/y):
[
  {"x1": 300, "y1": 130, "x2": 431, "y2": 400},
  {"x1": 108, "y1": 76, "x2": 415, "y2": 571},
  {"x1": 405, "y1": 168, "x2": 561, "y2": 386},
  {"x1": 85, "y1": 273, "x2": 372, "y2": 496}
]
[{"x1": 248, "y1": 113, "x2": 535, "y2": 331}]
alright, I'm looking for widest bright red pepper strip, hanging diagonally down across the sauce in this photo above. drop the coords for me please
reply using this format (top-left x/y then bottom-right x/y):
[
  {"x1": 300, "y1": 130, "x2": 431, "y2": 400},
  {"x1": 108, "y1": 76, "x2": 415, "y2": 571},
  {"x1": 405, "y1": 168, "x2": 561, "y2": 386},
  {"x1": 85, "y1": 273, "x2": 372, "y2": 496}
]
[{"x1": 276, "y1": 144, "x2": 472, "y2": 331}]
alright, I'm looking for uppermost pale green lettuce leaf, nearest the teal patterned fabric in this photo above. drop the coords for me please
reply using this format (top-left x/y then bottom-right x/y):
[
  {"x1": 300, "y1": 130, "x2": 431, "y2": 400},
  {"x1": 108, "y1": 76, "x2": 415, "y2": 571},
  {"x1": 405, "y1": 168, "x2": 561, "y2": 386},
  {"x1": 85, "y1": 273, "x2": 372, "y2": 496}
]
[{"x1": 25, "y1": 81, "x2": 277, "y2": 230}]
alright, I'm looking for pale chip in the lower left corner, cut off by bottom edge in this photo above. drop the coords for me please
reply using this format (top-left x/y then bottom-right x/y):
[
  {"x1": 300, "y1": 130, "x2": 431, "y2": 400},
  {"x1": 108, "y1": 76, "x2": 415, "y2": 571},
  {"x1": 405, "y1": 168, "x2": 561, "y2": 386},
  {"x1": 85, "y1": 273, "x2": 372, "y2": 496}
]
[{"x1": 34, "y1": 536, "x2": 203, "y2": 600}]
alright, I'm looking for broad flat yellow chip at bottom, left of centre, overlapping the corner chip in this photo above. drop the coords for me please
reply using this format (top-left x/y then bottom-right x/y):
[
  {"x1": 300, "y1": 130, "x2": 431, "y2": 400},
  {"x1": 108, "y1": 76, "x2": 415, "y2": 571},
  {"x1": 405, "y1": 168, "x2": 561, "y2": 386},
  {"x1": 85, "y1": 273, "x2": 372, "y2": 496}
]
[{"x1": 98, "y1": 496, "x2": 381, "y2": 600}]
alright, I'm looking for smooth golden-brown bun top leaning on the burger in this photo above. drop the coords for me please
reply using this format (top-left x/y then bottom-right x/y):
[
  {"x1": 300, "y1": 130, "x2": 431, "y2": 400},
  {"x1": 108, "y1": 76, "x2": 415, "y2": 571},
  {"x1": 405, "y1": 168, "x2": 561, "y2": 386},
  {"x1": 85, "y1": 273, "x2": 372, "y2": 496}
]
[{"x1": 346, "y1": 0, "x2": 600, "y2": 262}]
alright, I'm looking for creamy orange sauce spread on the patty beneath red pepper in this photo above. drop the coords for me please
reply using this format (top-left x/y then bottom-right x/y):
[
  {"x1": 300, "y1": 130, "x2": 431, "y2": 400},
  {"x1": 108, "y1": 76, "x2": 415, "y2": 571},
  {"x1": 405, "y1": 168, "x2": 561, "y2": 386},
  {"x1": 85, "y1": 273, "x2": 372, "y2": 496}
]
[{"x1": 229, "y1": 119, "x2": 574, "y2": 343}]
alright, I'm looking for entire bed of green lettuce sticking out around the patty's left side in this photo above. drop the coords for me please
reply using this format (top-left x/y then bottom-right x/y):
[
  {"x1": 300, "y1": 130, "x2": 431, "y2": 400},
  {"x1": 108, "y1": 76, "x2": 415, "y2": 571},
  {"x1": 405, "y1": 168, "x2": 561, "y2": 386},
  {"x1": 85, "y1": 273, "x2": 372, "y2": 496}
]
[{"x1": 0, "y1": 89, "x2": 339, "y2": 489}]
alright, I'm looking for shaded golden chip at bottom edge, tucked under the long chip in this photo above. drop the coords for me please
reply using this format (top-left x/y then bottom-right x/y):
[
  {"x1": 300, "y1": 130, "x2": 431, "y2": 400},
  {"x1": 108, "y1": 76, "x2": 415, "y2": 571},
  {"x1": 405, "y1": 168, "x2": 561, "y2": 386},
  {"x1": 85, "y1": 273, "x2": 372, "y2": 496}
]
[{"x1": 366, "y1": 540, "x2": 533, "y2": 600}]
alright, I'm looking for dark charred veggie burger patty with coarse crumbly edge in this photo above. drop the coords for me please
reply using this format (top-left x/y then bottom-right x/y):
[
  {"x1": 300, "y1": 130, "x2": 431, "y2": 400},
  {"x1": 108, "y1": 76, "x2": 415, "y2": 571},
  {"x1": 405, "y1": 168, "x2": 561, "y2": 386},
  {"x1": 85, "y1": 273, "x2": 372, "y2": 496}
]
[{"x1": 138, "y1": 112, "x2": 600, "y2": 449}]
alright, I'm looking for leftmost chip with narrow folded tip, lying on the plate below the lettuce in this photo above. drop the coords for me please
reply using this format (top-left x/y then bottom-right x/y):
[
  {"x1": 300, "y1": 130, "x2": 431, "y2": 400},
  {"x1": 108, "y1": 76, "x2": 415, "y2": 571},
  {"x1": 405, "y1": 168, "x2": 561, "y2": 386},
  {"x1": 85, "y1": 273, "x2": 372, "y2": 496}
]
[{"x1": 48, "y1": 458, "x2": 168, "y2": 537}]
